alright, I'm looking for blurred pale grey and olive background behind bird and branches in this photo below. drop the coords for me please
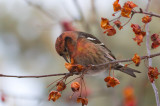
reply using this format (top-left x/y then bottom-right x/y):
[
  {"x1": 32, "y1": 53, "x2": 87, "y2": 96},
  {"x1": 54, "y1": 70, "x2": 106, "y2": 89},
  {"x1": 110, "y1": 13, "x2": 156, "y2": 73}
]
[{"x1": 0, "y1": 0, "x2": 160, "y2": 106}]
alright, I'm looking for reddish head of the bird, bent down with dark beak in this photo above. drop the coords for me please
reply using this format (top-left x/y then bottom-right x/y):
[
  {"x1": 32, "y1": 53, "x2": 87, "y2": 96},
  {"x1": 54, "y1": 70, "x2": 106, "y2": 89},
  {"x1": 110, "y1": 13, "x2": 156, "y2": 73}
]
[{"x1": 55, "y1": 31, "x2": 78, "y2": 62}]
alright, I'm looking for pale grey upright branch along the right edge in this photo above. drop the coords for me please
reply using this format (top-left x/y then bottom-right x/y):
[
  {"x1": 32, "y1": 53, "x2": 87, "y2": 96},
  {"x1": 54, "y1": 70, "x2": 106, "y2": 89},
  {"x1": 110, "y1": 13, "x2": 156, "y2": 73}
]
[{"x1": 145, "y1": 0, "x2": 160, "y2": 106}]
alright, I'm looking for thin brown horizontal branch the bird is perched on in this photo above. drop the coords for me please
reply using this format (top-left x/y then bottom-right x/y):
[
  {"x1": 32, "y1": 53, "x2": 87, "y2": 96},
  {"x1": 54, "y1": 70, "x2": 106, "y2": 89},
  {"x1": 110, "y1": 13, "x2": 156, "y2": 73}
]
[{"x1": 0, "y1": 53, "x2": 160, "y2": 78}]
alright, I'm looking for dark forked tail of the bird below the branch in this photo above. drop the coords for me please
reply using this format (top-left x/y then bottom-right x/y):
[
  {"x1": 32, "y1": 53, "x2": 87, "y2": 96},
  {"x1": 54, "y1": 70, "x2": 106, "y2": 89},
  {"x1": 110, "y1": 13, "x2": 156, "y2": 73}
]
[{"x1": 114, "y1": 64, "x2": 141, "y2": 77}]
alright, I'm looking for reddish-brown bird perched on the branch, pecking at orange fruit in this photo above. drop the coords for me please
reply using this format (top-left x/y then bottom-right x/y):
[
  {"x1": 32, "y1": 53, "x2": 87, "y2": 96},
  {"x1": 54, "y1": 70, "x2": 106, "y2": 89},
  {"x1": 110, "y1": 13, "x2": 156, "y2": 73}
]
[{"x1": 55, "y1": 31, "x2": 140, "y2": 77}]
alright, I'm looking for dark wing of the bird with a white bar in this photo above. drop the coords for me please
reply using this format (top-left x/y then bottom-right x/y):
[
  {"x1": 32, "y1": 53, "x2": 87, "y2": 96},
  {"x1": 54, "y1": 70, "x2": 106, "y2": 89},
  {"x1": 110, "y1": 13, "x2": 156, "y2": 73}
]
[{"x1": 77, "y1": 32, "x2": 116, "y2": 60}]
